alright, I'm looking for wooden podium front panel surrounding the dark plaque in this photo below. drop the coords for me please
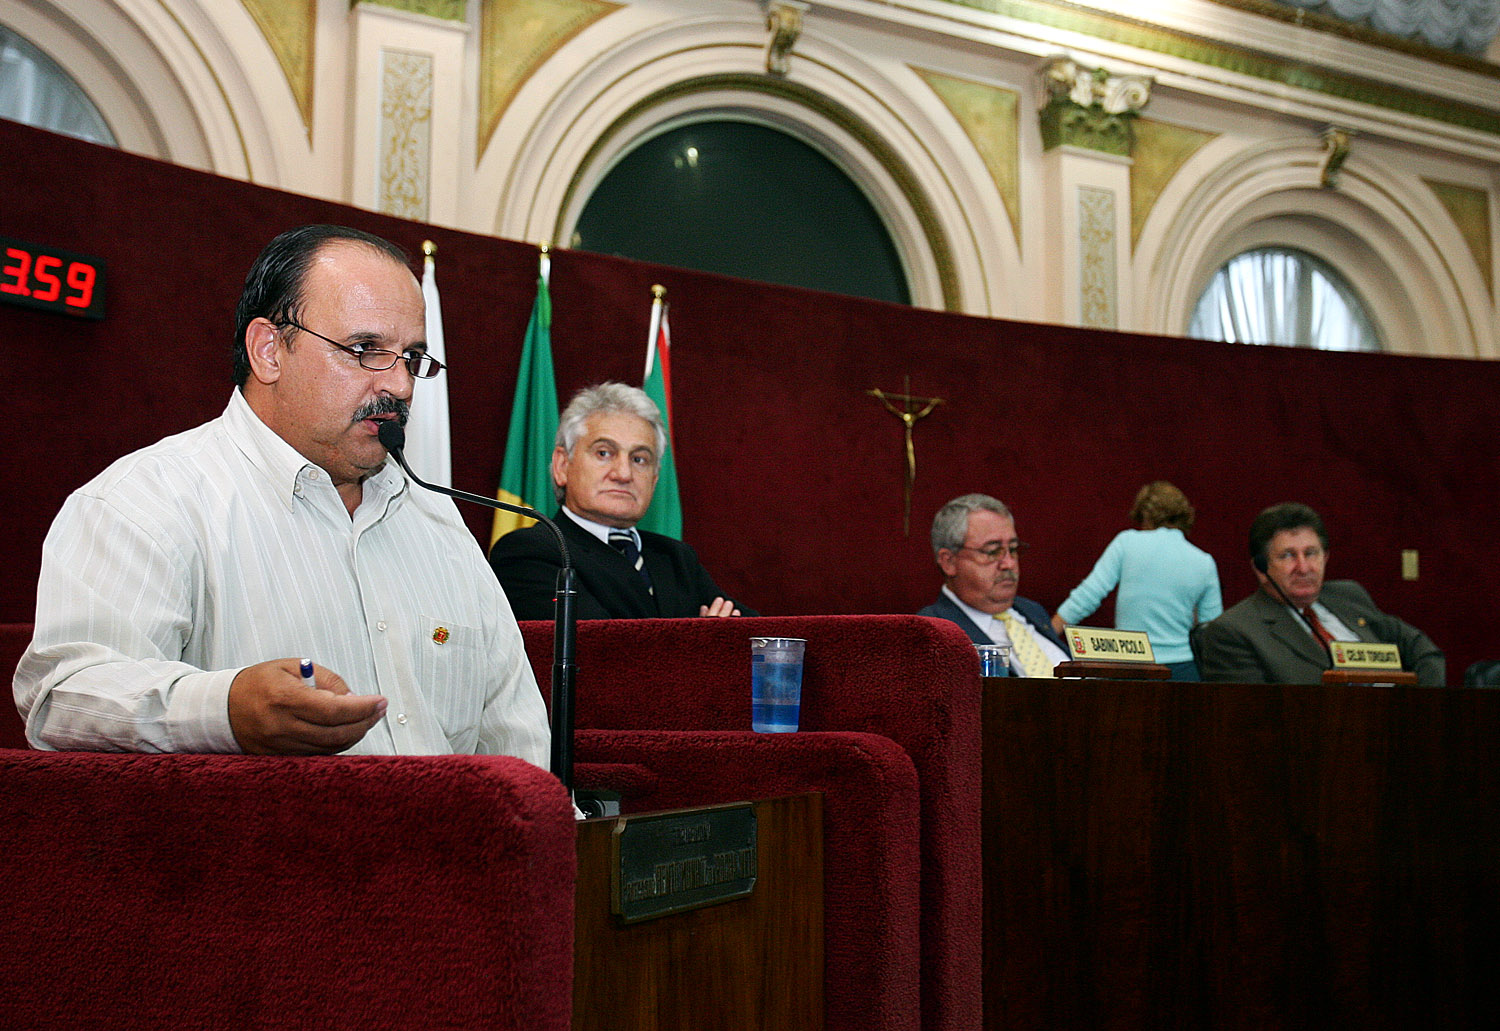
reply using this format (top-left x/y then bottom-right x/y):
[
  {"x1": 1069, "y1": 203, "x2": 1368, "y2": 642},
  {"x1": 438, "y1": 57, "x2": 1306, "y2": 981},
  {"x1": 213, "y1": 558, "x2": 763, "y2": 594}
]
[{"x1": 573, "y1": 794, "x2": 824, "y2": 1031}]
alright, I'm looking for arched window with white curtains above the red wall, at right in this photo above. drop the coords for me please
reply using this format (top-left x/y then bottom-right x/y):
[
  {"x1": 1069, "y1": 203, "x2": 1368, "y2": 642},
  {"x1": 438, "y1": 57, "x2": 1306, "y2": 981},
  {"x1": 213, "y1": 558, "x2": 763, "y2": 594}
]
[{"x1": 1188, "y1": 248, "x2": 1380, "y2": 351}]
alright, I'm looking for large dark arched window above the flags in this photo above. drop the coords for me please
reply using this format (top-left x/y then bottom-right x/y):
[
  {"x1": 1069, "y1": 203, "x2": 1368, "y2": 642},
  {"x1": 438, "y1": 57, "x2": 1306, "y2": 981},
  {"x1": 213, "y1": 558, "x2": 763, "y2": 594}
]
[{"x1": 572, "y1": 120, "x2": 911, "y2": 305}]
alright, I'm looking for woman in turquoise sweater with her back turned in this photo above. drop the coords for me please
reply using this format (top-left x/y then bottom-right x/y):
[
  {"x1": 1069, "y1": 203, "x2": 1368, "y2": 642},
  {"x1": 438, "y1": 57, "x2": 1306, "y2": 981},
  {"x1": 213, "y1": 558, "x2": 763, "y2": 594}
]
[{"x1": 1052, "y1": 480, "x2": 1224, "y2": 680}]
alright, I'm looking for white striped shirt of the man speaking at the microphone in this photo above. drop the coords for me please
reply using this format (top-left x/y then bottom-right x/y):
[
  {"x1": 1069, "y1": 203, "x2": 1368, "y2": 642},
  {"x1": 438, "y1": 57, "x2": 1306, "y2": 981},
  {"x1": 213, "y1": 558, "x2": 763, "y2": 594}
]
[{"x1": 15, "y1": 390, "x2": 549, "y2": 767}]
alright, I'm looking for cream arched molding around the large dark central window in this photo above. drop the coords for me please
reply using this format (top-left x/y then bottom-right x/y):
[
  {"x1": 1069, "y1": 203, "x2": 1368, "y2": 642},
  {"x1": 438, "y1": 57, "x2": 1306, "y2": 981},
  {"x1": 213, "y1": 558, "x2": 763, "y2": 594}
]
[{"x1": 477, "y1": 8, "x2": 1038, "y2": 318}]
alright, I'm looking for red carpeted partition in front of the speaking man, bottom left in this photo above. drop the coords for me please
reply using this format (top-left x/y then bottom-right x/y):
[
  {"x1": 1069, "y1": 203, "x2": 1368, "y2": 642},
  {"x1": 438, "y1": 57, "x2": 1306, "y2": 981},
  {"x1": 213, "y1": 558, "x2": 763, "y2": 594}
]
[{"x1": 0, "y1": 750, "x2": 576, "y2": 1031}]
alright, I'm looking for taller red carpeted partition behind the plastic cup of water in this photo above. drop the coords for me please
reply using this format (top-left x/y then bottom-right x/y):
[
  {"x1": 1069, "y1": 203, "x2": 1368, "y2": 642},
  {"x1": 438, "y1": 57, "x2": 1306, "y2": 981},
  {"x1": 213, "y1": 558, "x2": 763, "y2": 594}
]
[{"x1": 522, "y1": 615, "x2": 981, "y2": 1031}]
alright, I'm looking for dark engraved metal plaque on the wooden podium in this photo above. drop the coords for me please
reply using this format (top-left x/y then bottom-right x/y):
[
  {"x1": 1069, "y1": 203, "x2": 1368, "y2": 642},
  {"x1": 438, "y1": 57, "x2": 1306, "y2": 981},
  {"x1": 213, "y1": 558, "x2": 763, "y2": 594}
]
[{"x1": 611, "y1": 801, "x2": 756, "y2": 923}]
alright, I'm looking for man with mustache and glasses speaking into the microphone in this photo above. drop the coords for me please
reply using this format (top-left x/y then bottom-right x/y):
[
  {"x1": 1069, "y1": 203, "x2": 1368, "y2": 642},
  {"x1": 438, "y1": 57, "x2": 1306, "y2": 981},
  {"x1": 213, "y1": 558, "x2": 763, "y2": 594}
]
[{"x1": 15, "y1": 225, "x2": 549, "y2": 767}]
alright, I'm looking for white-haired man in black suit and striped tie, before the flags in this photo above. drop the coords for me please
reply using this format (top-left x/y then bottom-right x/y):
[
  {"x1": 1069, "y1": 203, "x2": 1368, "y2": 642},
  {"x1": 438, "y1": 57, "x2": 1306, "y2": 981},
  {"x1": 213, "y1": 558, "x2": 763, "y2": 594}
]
[{"x1": 489, "y1": 383, "x2": 755, "y2": 620}]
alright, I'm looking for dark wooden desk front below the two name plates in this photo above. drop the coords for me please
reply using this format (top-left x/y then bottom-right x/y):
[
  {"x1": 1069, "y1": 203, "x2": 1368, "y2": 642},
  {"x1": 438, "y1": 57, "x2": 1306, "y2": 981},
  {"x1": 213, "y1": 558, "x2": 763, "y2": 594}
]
[{"x1": 984, "y1": 680, "x2": 1500, "y2": 1031}]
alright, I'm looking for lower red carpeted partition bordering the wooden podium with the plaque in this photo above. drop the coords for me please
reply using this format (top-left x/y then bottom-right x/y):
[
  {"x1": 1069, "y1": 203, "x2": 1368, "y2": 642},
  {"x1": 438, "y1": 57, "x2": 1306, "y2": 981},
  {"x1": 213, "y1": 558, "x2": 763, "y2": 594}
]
[{"x1": 576, "y1": 731, "x2": 921, "y2": 1031}]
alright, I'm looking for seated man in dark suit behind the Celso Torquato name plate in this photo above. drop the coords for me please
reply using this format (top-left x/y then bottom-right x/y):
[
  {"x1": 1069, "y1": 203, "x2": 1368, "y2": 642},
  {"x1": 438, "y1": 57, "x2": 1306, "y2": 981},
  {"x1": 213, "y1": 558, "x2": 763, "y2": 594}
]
[{"x1": 1199, "y1": 503, "x2": 1448, "y2": 687}]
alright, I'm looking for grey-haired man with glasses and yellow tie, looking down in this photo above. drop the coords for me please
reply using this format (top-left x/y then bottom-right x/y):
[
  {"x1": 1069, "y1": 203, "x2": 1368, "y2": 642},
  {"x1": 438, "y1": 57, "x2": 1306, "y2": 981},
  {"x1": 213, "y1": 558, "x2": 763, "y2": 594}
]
[{"x1": 918, "y1": 494, "x2": 1068, "y2": 677}]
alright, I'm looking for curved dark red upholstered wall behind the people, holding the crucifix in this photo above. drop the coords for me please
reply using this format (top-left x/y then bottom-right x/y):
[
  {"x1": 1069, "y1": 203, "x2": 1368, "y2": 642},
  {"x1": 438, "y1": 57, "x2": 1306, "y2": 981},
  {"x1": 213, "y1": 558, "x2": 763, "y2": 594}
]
[{"x1": 0, "y1": 122, "x2": 1500, "y2": 680}]
